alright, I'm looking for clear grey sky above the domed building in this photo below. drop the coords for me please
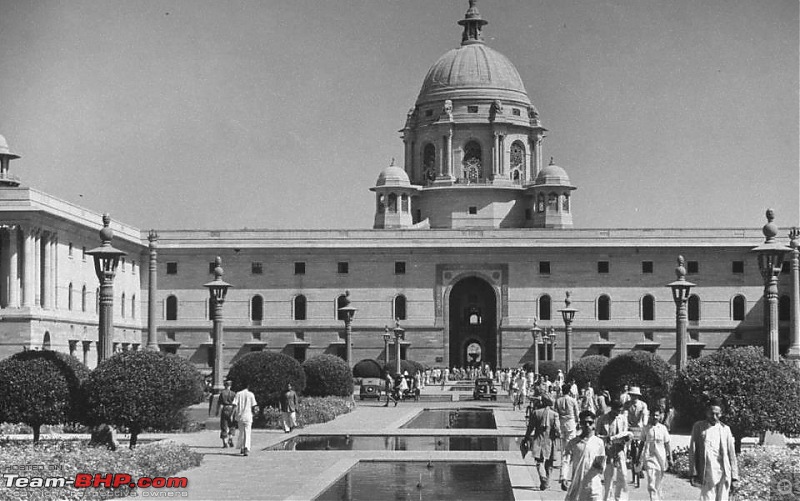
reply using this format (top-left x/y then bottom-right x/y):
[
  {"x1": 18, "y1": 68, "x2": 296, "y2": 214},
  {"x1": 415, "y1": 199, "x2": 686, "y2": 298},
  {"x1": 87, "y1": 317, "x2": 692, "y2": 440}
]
[{"x1": 0, "y1": 0, "x2": 800, "y2": 229}]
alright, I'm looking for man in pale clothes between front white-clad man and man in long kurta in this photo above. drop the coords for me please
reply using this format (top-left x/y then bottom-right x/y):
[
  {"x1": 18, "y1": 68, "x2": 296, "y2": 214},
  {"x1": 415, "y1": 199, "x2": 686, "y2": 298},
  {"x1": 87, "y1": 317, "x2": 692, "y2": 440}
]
[{"x1": 597, "y1": 400, "x2": 631, "y2": 501}]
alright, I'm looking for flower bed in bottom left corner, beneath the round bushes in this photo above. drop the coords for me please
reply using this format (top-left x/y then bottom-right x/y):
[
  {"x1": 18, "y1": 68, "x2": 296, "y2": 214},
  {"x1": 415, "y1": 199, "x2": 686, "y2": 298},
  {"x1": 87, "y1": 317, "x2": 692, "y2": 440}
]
[{"x1": 0, "y1": 440, "x2": 202, "y2": 500}]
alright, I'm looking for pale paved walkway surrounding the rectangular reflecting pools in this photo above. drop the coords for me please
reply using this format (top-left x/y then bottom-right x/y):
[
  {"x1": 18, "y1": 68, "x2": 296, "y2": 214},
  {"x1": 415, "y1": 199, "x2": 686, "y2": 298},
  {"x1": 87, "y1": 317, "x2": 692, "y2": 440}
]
[{"x1": 161, "y1": 389, "x2": 699, "y2": 501}]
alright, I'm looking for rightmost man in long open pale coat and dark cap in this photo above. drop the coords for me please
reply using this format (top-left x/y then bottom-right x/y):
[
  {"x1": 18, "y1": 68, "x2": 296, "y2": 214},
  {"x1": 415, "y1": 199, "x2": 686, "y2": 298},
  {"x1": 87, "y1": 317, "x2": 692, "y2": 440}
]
[{"x1": 689, "y1": 400, "x2": 739, "y2": 501}]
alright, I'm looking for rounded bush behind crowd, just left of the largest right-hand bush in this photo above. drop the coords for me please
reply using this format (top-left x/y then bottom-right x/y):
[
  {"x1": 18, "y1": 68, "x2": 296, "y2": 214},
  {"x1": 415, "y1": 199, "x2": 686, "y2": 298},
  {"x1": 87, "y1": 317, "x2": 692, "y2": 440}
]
[{"x1": 595, "y1": 350, "x2": 675, "y2": 408}]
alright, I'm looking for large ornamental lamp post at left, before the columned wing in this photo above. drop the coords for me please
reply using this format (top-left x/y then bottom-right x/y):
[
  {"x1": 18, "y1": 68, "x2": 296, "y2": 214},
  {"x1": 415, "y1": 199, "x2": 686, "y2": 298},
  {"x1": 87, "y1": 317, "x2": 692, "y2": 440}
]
[{"x1": 86, "y1": 214, "x2": 125, "y2": 364}]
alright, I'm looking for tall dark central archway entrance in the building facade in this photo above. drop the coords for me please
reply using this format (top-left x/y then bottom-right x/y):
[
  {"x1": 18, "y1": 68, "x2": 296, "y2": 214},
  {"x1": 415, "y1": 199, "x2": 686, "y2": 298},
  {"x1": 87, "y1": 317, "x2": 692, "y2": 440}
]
[{"x1": 449, "y1": 277, "x2": 497, "y2": 369}]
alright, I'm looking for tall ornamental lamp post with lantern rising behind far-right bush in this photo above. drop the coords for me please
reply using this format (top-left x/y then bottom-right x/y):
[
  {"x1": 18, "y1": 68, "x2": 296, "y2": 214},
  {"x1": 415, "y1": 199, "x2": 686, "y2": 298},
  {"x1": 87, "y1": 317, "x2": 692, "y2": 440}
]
[{"x1": 751, "y1": 209, "x2": 791, "y2": 362}]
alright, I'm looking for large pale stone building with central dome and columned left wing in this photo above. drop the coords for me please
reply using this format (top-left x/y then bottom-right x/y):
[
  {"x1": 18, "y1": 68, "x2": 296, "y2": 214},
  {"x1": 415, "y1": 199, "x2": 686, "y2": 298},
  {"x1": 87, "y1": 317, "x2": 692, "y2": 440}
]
[{"x1": 0, "y1": 5, "x2": 790, "y2": 368}]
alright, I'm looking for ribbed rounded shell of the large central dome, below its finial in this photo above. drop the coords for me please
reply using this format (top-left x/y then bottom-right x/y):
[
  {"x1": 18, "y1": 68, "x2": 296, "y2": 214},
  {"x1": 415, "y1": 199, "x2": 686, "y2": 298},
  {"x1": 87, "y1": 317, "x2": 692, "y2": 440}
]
[{"x1": 416, "y1": 43, "x2": 531, "y2": 106}]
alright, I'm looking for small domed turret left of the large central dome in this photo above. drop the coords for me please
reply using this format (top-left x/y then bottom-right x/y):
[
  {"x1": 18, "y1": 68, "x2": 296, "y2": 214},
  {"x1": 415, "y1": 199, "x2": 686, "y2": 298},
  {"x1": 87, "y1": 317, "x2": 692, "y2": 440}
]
[{"x1": 370, "y1": 158, "x2": 419, "y2": 229}]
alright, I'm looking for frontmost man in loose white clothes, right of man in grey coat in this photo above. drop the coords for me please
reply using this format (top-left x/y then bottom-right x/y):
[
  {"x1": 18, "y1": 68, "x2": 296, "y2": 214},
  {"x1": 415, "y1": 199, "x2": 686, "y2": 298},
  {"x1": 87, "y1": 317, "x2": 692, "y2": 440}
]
[{"x1": 561, "y1": 411, "x2": 606, "y2": 501}]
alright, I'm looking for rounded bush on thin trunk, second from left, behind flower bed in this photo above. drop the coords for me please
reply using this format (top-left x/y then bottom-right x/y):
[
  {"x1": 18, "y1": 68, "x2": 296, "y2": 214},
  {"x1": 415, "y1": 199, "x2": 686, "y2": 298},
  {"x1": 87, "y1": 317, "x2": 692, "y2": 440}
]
[{"x1": 84, "y1": 351, "x2": 203, "y2": 449}]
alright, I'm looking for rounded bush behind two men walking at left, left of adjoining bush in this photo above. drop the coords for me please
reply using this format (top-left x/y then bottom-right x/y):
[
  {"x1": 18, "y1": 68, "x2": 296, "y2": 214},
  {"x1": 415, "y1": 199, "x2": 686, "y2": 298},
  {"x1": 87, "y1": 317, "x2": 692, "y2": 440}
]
[{"x1": 228, "y1": 351, "x2": 306, "y2": 409}]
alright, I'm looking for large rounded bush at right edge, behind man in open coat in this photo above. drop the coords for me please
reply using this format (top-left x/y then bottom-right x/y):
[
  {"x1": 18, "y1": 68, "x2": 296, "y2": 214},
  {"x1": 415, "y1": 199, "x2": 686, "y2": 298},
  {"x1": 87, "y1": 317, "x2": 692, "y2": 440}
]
[{"x1": 672, "y1": 346, "x2": 800, "y2": 452}]
